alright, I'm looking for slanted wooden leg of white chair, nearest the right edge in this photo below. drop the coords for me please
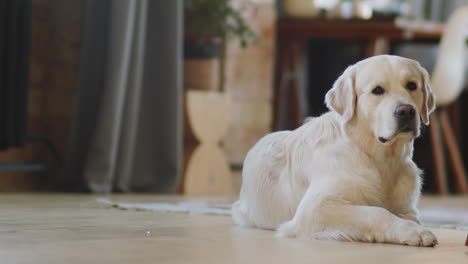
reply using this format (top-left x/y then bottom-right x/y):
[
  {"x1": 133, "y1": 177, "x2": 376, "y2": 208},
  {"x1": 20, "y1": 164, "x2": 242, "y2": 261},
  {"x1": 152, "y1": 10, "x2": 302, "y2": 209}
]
[{"x1": 440, "y1": 108, "x2": 468, "y2": 194}]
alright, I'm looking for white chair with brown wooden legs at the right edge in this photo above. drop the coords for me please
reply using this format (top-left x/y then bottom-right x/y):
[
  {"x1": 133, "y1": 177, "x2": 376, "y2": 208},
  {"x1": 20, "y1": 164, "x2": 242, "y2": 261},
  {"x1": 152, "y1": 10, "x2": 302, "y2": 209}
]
[{"x1": 430, "y1": 6, "x2": 468, "y2": 194}]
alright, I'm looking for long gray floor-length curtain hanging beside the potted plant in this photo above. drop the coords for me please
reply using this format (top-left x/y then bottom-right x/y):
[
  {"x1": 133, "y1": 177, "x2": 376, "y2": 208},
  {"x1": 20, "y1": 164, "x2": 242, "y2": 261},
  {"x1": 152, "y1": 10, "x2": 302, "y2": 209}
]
[{"x1": 67, "y1": 0, "x2": 183, "y2": 193}]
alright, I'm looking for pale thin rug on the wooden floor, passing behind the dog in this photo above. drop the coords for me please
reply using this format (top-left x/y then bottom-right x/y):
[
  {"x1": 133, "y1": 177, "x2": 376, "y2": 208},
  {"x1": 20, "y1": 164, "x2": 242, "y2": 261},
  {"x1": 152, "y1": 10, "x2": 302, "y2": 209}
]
[{"x1": 91, "y1": 198, "x2": 468, "y2": 230}]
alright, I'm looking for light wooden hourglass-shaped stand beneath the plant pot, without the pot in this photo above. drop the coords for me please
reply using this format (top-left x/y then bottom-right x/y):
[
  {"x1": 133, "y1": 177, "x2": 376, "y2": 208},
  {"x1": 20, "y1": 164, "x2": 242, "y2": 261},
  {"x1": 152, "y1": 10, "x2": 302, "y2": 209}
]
[{"x1": 184, "y1": 90, "x2": 232, "y2": 194}]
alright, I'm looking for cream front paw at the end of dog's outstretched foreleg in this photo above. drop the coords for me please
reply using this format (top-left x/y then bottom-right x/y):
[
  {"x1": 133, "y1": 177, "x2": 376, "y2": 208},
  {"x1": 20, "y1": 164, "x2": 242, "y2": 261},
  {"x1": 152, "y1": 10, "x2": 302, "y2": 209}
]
[{"x1": 400, "y1": 222, "x2": 438, "y2": 247}]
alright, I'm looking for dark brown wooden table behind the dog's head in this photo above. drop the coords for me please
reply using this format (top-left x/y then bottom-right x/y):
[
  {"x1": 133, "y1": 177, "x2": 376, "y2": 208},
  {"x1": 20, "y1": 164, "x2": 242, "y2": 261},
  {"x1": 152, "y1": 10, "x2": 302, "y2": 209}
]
[{"x1": 273, "y1": 18, "x2": 443, "y2": 131}]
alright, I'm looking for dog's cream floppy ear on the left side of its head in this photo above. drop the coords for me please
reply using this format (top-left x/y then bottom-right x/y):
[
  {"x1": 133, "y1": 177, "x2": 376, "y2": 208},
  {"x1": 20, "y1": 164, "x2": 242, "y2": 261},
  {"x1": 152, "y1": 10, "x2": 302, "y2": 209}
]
[{"x1": 325, "y1": 66, "x2": 356, "y2": 122}]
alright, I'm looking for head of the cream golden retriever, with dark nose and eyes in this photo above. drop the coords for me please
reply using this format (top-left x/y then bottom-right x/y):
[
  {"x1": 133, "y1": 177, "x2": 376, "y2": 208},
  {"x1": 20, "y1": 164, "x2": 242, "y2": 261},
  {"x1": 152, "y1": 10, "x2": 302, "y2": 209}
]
[{"x1": 325, "y1": 55, "x2": 435, "y2": 144}]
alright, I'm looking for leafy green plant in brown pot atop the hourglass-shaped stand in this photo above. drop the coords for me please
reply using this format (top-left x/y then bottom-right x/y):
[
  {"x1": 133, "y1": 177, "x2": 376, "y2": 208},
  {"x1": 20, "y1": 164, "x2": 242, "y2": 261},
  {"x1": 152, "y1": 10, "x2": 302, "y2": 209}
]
[{"x1": 184, "y1": 0, "x2": 255, "y2": 90}]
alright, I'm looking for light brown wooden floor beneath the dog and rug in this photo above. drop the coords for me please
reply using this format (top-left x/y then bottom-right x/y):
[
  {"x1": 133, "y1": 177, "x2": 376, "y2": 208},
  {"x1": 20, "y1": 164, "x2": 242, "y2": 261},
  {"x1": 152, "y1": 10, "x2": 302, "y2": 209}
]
[{"x1": 0, "y1": 194, "x2": 468, "y2": 264}]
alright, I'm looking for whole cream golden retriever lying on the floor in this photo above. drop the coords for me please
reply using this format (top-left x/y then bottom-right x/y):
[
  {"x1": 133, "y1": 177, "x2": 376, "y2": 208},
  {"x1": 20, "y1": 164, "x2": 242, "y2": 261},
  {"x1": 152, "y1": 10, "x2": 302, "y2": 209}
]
[{"x1": 232, "y1": 55, "x2": 437, "y2": 247}]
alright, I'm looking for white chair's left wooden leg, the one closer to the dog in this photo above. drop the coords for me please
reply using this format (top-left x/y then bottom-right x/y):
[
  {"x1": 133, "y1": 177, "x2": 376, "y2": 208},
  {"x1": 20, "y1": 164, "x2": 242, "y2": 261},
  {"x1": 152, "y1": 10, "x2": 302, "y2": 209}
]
[{"x1": 429, "y1": 112, "x2": 448, "y2": 194}]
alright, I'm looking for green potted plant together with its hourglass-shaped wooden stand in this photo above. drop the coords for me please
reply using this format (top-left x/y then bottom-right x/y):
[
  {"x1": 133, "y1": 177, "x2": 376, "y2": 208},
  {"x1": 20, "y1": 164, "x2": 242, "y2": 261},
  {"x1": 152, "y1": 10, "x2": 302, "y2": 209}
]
[{"x1": 179, "y1": 0, "x2": 255, "y2": 194}]
